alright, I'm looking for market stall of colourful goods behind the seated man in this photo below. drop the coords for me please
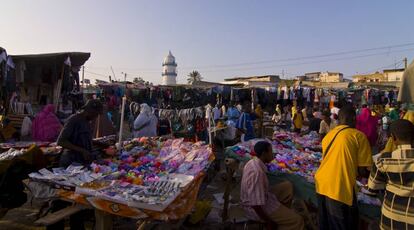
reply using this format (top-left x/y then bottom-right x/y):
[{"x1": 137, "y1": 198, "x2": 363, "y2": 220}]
[{"x1": 223, "y1": 132, "x2": 381, "y2": 223}]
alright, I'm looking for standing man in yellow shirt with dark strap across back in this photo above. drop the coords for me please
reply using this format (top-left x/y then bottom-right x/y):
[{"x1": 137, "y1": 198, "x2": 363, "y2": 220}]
[{"x1": 315, "y1": 106, "x2": 372, "y2": 230}]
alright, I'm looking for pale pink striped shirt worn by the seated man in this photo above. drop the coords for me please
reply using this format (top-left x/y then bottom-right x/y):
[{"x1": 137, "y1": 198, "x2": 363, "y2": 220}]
[{"x1": 240, "y1": 157, "x2": 280, "y2": 220}]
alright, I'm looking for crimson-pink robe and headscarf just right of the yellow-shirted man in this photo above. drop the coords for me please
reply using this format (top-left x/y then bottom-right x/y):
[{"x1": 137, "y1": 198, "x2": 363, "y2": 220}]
[{"x1": 356, "y1": 108, "x2": 378, "y2": 146}]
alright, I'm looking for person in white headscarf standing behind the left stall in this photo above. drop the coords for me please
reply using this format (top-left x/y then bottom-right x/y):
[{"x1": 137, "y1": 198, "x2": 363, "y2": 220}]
[{"x1": 133, "y1": 103, "x2": 158, "y2": 138}]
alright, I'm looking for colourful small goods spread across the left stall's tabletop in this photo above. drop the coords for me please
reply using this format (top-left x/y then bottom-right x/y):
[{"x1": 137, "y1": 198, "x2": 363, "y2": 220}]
[{"x1": 30, "y1": 138, "x2": 214, "y2": 211}]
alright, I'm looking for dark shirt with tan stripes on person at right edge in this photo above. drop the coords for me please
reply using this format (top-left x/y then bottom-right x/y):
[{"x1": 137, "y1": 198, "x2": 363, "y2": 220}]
[{"x1": 368, "y1": 145, "x2": 414, "y2": 229}]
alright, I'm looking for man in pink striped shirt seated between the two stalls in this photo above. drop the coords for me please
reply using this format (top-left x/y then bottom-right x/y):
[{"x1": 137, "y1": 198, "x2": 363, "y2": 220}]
[{"x1": 240, "y1": 141, "x2": 304, "y2": 230}]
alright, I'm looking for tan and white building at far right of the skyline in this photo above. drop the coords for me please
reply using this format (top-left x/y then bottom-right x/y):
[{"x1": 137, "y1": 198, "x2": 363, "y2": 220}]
[{"x1": 352, "y1": 69, "x2": 404, "y2": 83}]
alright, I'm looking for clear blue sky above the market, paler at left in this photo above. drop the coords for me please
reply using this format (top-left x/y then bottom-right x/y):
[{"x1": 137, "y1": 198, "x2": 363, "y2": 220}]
[{"x1": 0, "y1": 0, "x2": 414, "y2": 84}]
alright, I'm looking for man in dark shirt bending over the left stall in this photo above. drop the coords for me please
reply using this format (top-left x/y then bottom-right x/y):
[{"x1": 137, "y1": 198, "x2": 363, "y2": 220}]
[{"x1": 57, "y1": 100, "x2": 103, "y2": 167}]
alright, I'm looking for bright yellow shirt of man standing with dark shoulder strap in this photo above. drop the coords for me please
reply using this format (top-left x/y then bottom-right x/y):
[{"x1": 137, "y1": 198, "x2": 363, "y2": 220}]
[{"x1": 315, "y1": 125, "x2": 372, "y2": 206}]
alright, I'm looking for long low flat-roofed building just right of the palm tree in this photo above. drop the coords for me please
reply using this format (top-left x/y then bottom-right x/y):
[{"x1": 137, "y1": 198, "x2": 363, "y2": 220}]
[{"x1": 222, "y1": 75, "x2": 280, "y2": 88}]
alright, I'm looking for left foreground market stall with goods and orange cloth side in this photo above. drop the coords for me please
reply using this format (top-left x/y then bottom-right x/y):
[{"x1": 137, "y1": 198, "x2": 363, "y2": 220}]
[{"x1": 29, "y1": 138, "x2": 214, "y2": 229}]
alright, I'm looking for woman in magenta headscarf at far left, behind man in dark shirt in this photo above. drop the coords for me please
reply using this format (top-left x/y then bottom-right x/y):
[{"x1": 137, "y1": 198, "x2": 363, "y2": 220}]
[{"x1": 32, "y1": 104, "x2": 62, "y2": 142}]
